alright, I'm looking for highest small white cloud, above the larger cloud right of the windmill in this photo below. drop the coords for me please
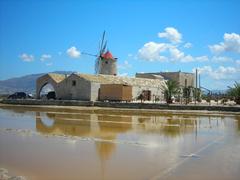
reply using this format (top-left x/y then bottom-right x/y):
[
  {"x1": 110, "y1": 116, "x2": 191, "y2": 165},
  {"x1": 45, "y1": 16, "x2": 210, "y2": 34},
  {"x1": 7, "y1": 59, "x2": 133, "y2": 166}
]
[{"x1": 158, "y1": 27, "x2": 182, "y2": 43}]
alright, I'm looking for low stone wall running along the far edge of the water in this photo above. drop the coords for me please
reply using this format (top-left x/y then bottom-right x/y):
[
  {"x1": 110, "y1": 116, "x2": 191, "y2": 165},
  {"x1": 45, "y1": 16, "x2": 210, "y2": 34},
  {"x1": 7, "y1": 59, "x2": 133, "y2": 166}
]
[{"x1": 0, "y1": 99, "x2": 240, "y2": 112}]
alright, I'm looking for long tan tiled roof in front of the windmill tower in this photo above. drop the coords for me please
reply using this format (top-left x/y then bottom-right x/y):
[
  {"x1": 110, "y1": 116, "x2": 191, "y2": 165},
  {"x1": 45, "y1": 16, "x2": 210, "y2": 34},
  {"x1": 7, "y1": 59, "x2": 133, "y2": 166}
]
[{"x1": 75, "y1": 74, "x2": 165, "y2": 87}]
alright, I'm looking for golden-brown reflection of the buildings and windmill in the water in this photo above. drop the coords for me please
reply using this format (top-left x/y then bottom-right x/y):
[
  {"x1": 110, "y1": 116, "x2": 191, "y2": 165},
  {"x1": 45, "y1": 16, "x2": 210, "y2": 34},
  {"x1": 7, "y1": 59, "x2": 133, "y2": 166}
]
[{"x1": 33, "y1": 112, "x2": 227, "y2": 160}]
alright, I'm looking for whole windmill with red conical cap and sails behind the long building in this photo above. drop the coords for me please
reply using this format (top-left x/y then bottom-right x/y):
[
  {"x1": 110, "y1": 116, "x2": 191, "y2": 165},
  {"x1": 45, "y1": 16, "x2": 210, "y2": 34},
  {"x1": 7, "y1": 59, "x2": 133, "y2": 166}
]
[{"x1": 82, "y1": 31, "x2": 117, "y2": 75}]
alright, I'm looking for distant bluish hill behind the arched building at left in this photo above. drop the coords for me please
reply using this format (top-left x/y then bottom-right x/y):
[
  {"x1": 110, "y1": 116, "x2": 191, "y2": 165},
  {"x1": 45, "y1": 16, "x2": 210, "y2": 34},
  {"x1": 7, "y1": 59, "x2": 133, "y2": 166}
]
[{"x1": 0, "y1": 71, "x2": 73, "y2": 94}]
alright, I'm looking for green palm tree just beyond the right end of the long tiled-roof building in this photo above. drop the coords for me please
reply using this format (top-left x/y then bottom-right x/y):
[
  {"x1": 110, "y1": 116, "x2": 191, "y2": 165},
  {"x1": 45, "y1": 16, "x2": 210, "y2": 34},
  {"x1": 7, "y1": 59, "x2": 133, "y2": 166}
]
[{"x1": 162, "y1": 80, "x2": 179, "y2": 104}]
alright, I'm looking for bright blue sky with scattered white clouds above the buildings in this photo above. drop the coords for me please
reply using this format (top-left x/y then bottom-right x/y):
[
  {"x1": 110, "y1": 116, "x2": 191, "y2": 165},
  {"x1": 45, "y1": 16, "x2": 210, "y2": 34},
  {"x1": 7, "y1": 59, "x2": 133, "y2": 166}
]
[{"x1": 0, "y1": 0, "x2": 240, "y2": 89}]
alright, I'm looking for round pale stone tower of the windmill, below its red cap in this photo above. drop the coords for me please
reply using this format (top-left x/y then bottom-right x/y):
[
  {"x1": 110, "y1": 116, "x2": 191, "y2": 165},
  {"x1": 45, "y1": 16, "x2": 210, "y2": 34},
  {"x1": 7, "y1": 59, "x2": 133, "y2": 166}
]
[{"x1": 99, "y1": 59, "x2": 117, "y2": 75}]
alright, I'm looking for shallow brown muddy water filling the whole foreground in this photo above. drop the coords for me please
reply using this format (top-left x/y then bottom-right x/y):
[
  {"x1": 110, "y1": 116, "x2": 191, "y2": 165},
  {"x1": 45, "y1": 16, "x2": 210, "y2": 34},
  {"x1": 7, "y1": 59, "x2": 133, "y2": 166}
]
[{"x1": 0, "y1": 107, "x2": 240, "y2": 180}]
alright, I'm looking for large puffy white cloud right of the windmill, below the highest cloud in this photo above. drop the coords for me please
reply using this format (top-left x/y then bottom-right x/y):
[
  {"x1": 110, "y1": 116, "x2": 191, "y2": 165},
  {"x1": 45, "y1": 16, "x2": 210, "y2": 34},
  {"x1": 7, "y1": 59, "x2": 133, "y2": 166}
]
[{"x1": 138, "y1": 42, "x2": 169, "y2": 61}]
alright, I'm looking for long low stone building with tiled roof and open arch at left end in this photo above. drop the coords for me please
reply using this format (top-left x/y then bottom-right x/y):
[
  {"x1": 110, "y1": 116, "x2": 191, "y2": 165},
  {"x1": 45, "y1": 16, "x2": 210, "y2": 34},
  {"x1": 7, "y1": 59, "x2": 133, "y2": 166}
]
[{"x1": 36, "y1": 73, "x2": 165, "y2": 101}]
